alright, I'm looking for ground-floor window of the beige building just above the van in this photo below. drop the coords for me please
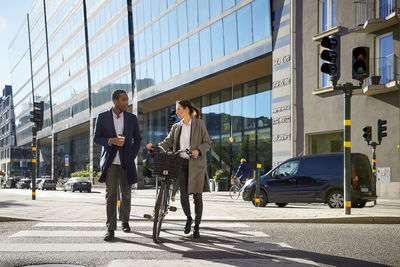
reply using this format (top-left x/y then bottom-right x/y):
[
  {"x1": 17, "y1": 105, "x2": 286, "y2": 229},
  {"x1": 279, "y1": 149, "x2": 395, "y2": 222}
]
[{"x1": 307, "y1": 131, "x2": 343, "y2": 155}]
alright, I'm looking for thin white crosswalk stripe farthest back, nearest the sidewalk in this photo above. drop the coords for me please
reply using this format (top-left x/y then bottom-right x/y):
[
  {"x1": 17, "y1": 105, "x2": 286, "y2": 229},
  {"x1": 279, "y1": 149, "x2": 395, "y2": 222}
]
[{"x1": 33, "y1": 221, "x2": 249, "y2": 229}]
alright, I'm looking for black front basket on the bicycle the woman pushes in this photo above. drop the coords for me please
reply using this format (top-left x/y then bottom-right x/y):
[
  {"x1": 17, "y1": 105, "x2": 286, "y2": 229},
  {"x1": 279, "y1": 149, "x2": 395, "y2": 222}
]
[{"x1": 153, "y1": 153, "x2": 184, "y2": 179}]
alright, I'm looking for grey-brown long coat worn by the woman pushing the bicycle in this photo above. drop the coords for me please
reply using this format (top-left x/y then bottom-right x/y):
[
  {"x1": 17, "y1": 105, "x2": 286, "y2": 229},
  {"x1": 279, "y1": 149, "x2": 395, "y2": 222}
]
[{"x1": 159, "y1": 118, "x2": 211, "y2": 194}]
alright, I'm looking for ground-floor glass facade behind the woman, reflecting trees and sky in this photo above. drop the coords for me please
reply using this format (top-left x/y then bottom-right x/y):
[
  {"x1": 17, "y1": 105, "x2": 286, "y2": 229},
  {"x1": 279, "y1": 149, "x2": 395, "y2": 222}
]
[{"x1": 142, "y1": 76, "x2": 272, "y2": 177}]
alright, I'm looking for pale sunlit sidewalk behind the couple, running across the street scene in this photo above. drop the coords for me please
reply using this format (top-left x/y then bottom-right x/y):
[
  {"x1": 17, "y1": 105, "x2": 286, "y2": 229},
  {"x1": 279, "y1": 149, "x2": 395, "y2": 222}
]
[{"x1": 0, "y1": 187, "x2": 400, "y2": 224}]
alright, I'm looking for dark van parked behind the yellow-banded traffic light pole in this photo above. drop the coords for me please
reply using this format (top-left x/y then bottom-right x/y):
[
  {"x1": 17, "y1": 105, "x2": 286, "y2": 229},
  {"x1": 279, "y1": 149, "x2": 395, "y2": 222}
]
[{"x1": 243, "y1": 153, "x2": 376, "y2": 208}]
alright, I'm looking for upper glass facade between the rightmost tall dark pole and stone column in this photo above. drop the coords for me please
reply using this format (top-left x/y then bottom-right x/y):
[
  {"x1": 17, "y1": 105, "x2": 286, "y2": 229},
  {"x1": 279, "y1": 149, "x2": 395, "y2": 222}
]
[{"x1": 133, "y1": 0, "x2": 271, "y2": 91}]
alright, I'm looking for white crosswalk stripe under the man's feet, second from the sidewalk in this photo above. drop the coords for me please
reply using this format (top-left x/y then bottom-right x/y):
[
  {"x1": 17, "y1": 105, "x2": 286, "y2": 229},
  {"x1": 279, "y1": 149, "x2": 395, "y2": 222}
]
[{"x1": 9, "y1": 229, "x2": 269, "y2": 238}]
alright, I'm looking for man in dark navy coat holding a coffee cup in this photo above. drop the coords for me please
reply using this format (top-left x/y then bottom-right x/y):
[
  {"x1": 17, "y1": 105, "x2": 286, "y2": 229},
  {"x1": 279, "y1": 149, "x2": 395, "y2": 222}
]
[{"x1": 93, "y1": 90, "x2": 141, "y2": 241}]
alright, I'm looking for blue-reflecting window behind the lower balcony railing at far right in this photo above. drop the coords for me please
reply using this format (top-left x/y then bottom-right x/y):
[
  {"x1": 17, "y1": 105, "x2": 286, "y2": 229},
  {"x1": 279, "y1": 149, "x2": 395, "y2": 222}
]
[{"x1": 377, "y1": 33, "x2": 395, "y2": 84}]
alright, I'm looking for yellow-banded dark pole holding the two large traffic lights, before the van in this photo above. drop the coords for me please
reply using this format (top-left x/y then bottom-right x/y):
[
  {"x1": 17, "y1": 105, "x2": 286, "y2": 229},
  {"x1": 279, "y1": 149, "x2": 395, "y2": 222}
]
[{"x1": 343, "y1": 83, "x2": 353, "y2": 214}]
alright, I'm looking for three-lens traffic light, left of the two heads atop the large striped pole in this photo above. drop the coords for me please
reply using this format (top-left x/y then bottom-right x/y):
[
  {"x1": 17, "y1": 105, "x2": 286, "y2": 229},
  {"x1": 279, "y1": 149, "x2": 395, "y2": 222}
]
[{"x1": 321, "y1": 35, "x2": 340, "y2": 82}]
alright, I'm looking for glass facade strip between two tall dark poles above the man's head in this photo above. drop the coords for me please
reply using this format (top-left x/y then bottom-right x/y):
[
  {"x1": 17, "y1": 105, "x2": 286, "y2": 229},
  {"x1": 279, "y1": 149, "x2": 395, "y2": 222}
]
[{"x1": 88, "y1": 0, "x2": 132, "y2": 108}]
